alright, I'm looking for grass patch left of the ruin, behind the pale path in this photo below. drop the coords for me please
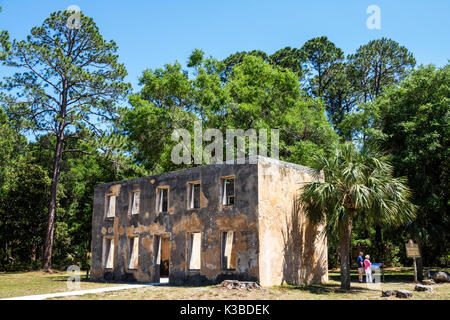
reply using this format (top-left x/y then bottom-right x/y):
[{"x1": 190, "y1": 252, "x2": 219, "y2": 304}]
[{"x1": 0, "y1": 271, "x2": 117, "y2": 299}]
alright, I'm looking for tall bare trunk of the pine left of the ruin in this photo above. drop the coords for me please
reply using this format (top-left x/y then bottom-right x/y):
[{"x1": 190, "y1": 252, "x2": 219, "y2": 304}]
[{"x1": 42, "y1": 132, "x2": 64, "y2": 271}]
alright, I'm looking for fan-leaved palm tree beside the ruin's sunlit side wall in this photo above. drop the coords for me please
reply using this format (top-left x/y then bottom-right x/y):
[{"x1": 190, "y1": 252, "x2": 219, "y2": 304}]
[{"x1": 299, "y1": 143, "x2": 416, "y2": 290}]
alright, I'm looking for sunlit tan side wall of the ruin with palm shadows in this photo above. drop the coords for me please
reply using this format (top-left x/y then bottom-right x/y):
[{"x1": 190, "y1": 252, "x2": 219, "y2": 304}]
[{"x1": 258, "y1": 159, "x2": 328, "y2": 286}]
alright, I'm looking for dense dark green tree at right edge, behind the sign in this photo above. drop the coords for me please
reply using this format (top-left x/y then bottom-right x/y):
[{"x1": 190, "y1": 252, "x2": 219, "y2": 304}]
[{"x1": 370, "y1": 65, "x2": 450, "y2": 265}]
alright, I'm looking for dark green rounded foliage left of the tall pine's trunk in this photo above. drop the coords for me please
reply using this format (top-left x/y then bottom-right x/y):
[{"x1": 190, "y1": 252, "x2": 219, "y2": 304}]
[{"x1": 0, "y1": 161, "x2": 50, "y2": 270}]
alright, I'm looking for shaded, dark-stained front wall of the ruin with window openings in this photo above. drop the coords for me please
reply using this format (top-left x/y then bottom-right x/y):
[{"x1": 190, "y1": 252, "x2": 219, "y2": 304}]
[{"x1": 91, "y1": 164, "x2": 259, "y2": 284}]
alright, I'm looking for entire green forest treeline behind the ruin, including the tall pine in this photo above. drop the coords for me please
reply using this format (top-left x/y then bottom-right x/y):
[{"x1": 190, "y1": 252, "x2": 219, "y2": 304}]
[{"x1": 0, "y1": 12, "x2": 450, "y2": 270}]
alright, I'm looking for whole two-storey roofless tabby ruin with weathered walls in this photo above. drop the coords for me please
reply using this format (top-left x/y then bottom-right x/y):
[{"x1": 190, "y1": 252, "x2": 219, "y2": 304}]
[{"x1": 91, "y1": 156, "x2": 328, "y2": 286}]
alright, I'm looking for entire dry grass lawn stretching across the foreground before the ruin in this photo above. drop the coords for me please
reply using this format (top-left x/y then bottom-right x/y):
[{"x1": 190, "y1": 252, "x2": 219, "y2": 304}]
[{"x1": 0, "y1": 268, "x2": 450, "y2": 300}]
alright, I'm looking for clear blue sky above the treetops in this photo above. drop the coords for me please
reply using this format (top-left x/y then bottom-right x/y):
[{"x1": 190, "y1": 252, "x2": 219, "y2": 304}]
[{"x1": 0, "y1": 0, "x2": 450, "y2": 89}]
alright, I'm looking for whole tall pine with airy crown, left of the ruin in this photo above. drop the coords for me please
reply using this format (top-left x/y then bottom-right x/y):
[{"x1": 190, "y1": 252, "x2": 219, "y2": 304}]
[{"x1": 1, "y1": 11, "x2": 129, "y2": 269}]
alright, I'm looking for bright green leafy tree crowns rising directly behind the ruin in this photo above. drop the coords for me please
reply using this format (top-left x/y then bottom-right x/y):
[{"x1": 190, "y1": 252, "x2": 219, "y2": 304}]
[{"x1": 123, "y1": 50, "x2": 336, "y2": 170}]
